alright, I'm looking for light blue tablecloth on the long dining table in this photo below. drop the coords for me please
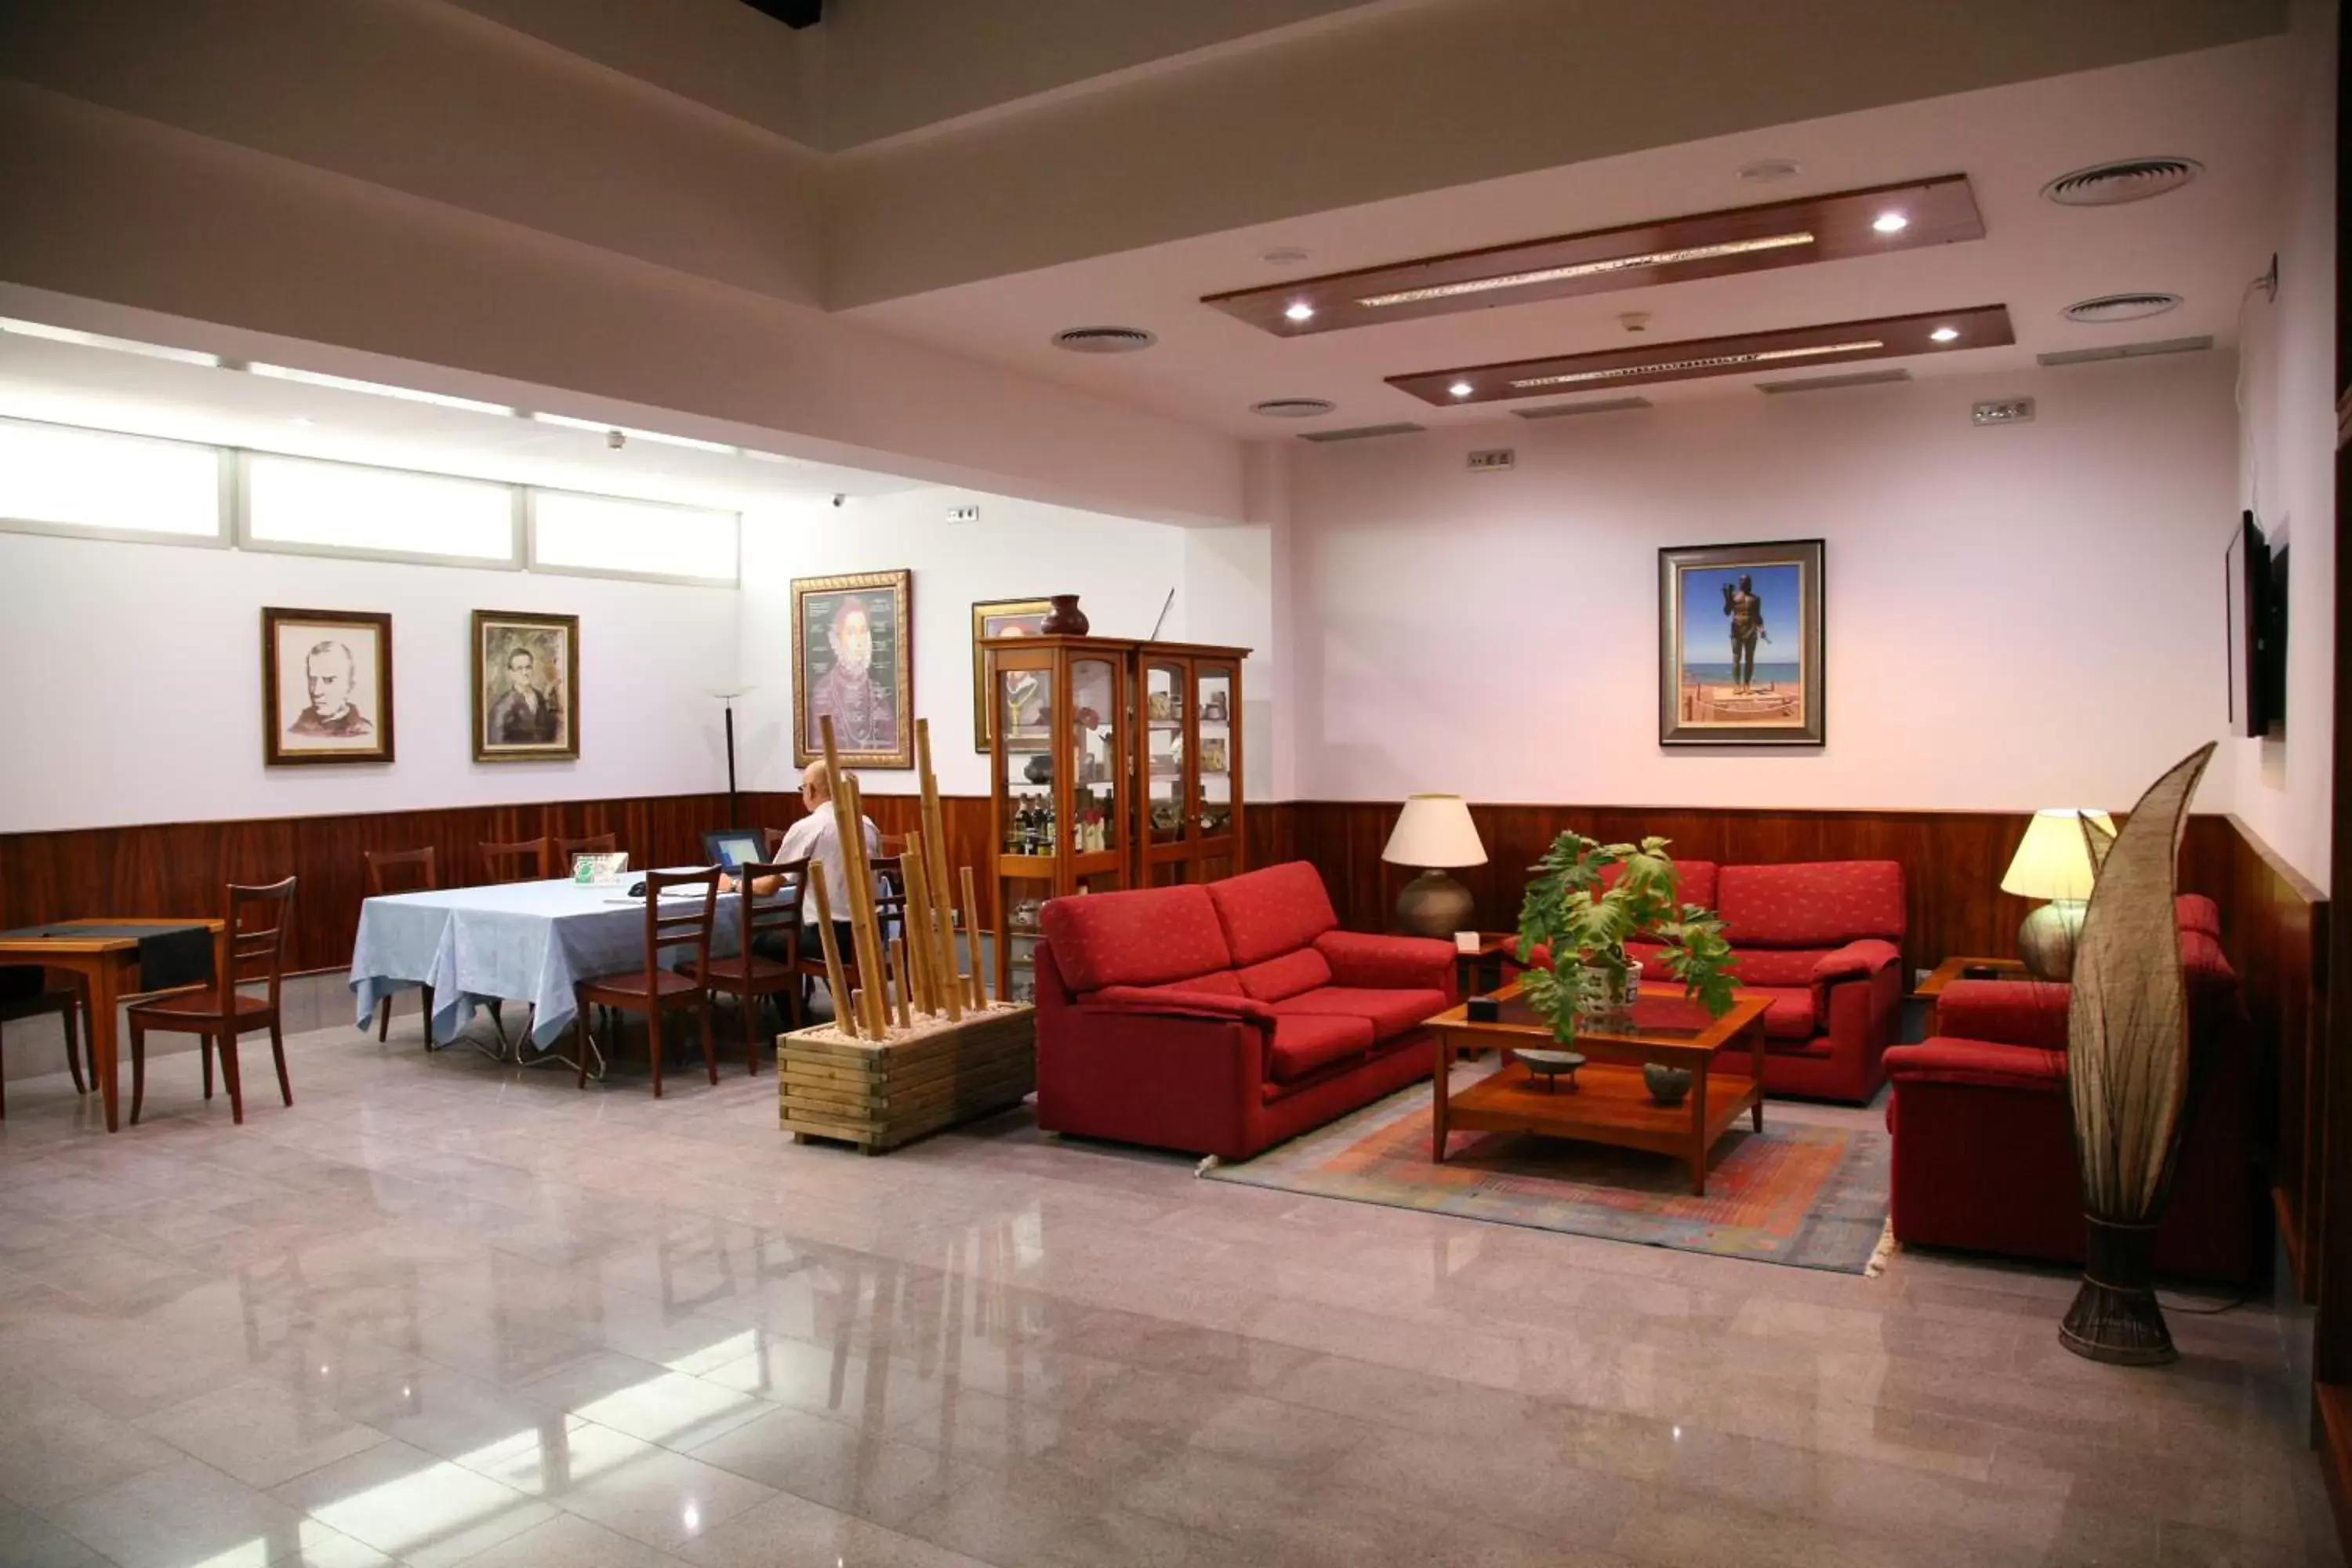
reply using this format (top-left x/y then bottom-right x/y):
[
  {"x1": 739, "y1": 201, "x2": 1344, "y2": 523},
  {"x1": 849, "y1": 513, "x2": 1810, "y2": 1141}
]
[{"x1": 350, "y1": 877, "x2": 739, "y2": 1048}]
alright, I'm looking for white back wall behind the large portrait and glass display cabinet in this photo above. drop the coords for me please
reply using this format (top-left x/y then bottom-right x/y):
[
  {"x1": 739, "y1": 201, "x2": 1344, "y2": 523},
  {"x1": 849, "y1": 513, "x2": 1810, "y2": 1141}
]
[{"x1": 736, "y1": 489, "x2": 1197, "y2": 794}]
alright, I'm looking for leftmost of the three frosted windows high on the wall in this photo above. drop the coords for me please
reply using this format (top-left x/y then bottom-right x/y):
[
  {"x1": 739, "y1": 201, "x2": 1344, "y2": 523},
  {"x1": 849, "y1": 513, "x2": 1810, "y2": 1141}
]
[{"x1": 0, "y1": 421, "x2": 221, "y2": 543}]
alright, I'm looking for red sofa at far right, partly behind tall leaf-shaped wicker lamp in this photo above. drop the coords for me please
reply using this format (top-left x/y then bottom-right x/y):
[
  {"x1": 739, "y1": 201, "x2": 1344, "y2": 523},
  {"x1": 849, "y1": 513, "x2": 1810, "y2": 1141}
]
[{"x1": 1886, "y1": 895, "x2": 2258, "y2": 1279}]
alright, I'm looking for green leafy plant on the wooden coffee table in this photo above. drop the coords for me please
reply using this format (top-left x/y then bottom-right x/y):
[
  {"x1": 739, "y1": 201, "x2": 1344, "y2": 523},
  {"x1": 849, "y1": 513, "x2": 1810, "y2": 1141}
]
[{"x1": 1519, "y1": 832, "x2": 1733, "y2": 1046}]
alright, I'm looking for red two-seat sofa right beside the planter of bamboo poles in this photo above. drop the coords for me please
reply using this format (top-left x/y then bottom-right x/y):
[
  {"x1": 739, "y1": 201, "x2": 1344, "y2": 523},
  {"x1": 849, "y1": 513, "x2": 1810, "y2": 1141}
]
[{"x1": 1035, "y1": 860, "x2": 1454, "y2": 1159}]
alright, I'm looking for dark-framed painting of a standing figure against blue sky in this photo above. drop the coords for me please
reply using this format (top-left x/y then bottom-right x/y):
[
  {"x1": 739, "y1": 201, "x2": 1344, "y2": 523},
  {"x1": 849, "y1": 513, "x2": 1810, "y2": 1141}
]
[{"x1": 1658, "y1": 539, "x2": 1825, "y2": 746}]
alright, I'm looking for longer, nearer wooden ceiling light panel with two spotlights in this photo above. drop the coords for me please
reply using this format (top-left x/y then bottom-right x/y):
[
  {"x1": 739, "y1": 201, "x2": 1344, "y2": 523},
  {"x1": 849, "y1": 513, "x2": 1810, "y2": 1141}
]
[{"x1": 1202, "y1": 174, "x2": 1985, "y2": 339}]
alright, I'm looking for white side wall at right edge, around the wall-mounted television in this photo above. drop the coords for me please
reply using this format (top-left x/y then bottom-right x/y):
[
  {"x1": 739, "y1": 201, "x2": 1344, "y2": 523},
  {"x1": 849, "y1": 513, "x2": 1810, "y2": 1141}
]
[{"x1": 2220, "y1": 2, "x2": 2338, "y2": 888}]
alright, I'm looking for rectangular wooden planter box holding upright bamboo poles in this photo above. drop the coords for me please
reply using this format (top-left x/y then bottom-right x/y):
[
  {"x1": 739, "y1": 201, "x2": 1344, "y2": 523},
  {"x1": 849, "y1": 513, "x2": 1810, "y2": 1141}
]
[{"x1": 776, "y1": 1001, "x2": 1037, "y2": 1154}]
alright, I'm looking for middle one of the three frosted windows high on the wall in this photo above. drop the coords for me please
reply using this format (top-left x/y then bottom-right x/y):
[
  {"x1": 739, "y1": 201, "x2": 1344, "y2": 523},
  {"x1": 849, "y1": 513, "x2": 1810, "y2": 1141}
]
[{"x1": 245, "y1": 454, "x2": 515, "y2": 564}]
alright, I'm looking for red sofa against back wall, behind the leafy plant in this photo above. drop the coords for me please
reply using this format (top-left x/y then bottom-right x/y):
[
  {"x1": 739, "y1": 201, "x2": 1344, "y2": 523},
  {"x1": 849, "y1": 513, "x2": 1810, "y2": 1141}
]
[{"x1": 1531, "y1": 860, "x2": 1903, "y2": 1105}]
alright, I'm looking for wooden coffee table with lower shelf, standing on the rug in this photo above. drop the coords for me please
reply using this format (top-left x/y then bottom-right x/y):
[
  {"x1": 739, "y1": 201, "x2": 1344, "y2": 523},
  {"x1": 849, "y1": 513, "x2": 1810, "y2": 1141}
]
[{"x1": 1428, "y1": 982, "x2": 1771, "y2": 1196}]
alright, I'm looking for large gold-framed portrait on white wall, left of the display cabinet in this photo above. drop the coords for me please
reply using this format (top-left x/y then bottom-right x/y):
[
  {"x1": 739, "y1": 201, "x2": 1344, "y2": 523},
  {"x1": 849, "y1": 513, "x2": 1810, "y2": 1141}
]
[{"x1": 793, "y1": 572, "x2": 915, "y2": 769}]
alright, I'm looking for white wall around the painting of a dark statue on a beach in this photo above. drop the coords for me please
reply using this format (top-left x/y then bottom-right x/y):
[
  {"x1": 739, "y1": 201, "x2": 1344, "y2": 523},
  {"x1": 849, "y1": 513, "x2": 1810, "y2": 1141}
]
[{"x1": 1284, "y1": 353, "x2": 2234, "y2": 808}]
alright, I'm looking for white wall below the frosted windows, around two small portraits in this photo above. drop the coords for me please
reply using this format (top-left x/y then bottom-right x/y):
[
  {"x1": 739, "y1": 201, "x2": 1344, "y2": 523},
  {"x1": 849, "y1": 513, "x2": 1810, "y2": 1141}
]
[{"x1": 0, "y1": 534, "x2": 736, "y2": 832}]
